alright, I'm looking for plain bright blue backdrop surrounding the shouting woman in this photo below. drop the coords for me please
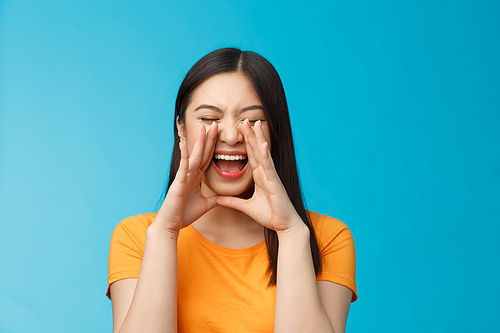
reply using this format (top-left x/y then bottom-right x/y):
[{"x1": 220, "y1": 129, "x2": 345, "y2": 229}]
[{"x1": 0, "y1": 0, "x2": 500, "y2": 332}]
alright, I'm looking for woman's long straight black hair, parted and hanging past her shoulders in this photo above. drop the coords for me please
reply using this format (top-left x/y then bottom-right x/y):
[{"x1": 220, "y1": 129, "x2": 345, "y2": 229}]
[{"x1": 165, "y1": 48, "x2": 321, "y2": 286}]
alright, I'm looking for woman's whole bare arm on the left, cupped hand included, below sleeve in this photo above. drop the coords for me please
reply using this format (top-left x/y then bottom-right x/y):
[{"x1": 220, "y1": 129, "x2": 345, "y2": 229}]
[{"x1": 110, "y1": 123, "x2": 217, "y2": 332}]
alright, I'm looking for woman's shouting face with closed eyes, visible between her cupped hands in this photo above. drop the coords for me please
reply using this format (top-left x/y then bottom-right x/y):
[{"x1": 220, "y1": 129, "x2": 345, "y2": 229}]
[{"x1": 177, "y1": 72, "x2": 271, "y2": 196}]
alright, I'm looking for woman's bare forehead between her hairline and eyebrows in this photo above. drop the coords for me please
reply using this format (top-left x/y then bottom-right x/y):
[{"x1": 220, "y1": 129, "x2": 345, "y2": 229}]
[{"x1": 188, "y1": 72, "x2": 261, "y2": 110}]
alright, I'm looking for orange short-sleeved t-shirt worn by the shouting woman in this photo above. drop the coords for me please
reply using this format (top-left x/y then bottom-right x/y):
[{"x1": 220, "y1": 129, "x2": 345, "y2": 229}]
[{"x1": 107, "y1": 212, "x2": 357, "y2": 332}]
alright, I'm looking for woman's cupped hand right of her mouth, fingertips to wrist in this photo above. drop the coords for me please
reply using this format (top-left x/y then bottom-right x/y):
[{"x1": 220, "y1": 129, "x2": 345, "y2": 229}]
[{"x1": 217, "y1": 119, "x2": 304, "y2": 233}]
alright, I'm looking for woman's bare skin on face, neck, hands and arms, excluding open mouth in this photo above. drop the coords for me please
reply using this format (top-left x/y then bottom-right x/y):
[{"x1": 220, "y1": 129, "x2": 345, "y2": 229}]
[{"x1": 111, "y1": 73, "x2": 352, "y2": 332}]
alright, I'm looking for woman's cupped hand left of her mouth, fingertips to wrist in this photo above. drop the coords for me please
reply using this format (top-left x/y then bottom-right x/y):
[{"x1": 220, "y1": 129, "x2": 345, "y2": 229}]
[{"x1": 151, "y1": 122, "x2": 217, "y2": 237}]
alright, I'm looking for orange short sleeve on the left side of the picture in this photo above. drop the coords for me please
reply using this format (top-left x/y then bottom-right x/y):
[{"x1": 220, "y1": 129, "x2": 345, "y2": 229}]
[{"x1": 106, "y1": 214, "x2": 152, "y2": 297}]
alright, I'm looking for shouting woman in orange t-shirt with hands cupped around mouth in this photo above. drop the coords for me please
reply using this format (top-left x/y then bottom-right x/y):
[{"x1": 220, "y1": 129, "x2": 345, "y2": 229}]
[{"x1": 108, "y1": 48, "x2": 357, "y2": 333}]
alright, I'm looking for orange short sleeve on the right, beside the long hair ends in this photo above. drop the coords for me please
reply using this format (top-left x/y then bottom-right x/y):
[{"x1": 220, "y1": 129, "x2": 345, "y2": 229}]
[{"x1": 309, "y1": 212, "x2": 358, "y2": 302}]
